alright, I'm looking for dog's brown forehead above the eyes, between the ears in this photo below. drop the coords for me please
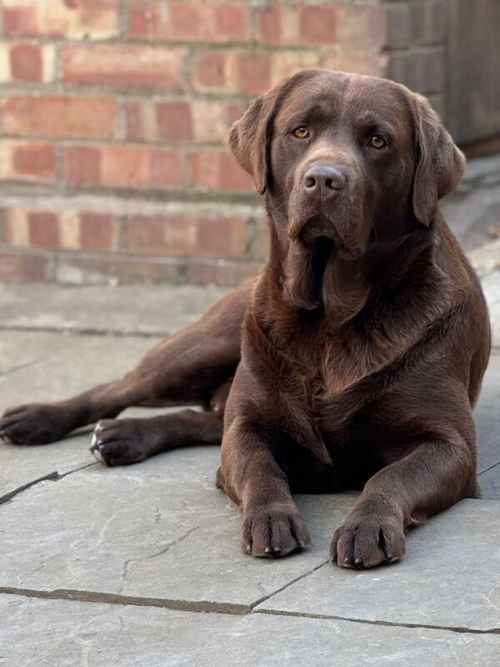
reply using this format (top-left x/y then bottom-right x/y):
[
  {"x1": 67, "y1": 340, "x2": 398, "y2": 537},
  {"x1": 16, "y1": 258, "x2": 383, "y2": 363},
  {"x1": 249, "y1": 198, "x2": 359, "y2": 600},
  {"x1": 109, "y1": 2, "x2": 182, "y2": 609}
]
[{"x1": 278, "y1": 71, "x2": 409, "y2": 126}]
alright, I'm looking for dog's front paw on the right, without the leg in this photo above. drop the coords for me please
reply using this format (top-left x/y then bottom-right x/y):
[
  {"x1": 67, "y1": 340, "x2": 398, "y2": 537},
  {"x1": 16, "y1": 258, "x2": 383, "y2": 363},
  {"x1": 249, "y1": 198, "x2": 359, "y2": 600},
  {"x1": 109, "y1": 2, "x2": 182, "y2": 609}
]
[{"x1": 331, "y1": 515, "x2": 405, "y2": 569}]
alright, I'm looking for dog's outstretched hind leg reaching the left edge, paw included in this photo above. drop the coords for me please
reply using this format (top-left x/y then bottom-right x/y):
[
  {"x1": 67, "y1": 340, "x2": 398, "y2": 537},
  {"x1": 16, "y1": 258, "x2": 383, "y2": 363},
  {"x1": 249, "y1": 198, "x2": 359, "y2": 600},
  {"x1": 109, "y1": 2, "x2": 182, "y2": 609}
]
[{"x1": 0, "y1": 283, "x2": 251, "y2": 445}]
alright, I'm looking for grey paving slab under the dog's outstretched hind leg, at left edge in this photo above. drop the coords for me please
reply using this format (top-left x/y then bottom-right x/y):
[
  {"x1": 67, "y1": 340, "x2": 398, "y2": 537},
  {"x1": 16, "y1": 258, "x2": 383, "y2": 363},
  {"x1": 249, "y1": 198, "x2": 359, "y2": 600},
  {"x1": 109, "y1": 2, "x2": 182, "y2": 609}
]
[{"x1": 0, "y1": 332, "x2": 159, "y2": 495}]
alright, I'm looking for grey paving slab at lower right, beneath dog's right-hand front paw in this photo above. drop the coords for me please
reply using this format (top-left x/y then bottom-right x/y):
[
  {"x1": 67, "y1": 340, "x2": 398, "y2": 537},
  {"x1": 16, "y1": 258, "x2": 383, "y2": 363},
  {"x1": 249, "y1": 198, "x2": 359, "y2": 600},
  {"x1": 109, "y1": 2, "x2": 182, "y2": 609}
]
[{"x1": 257, "y1": 500, "x2": 500, "y2": 632}]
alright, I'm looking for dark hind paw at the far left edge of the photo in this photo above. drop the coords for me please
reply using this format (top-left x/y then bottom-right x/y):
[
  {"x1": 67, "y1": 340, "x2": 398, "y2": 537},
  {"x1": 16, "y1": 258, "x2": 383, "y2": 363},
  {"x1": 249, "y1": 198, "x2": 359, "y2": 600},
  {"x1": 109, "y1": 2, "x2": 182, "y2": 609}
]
[{"x1": 0, "y1": 403, "x2": 71, "y2": 445}]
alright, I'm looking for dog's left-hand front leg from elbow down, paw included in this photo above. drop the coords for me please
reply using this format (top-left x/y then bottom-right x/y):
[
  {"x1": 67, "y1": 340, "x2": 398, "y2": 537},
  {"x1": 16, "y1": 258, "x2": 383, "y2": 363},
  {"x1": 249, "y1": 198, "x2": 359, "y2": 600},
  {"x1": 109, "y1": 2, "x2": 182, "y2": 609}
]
[{"x1": 219, "y1": 417, "x2": 310, "y2": 557}]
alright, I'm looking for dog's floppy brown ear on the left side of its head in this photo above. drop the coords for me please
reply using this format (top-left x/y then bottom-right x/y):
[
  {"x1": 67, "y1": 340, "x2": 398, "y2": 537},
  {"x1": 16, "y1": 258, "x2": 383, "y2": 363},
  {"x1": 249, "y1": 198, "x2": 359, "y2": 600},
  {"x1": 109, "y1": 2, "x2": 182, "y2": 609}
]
[{"x1": 229, "y1": 69, "x2": 321, "y2": 194}]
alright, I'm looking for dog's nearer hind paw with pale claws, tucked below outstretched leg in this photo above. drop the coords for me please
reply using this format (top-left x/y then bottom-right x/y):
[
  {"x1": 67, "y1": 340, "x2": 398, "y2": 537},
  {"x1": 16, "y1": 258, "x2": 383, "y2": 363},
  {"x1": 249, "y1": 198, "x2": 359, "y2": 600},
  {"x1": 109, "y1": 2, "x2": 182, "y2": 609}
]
[{"x1": 90, "y1": 419, "x2": 148, "y2": 466}]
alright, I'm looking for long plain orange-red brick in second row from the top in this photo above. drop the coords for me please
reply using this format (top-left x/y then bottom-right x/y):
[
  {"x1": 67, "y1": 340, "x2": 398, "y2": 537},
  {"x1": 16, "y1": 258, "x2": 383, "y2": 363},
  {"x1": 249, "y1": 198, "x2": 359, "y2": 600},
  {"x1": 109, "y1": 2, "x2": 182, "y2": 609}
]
[{"x1": 62, "y1": 44, "x2": 184, "y2": 90}]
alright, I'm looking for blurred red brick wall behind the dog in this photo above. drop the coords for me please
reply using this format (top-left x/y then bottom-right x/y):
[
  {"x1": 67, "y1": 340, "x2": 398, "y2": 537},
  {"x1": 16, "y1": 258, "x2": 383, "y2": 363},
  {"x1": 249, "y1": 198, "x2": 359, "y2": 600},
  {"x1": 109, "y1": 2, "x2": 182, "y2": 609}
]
[{"x1": 0, "y1": 0, "x2": 444, "y2": 285}]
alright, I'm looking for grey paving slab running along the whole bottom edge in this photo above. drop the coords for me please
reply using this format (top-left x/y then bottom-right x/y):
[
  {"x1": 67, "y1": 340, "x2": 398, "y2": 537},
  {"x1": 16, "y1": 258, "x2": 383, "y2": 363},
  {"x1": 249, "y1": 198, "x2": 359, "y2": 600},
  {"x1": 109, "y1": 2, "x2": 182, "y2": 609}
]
[{"x1": 0, "y1": 596, "x2": 500, "y2": 667}]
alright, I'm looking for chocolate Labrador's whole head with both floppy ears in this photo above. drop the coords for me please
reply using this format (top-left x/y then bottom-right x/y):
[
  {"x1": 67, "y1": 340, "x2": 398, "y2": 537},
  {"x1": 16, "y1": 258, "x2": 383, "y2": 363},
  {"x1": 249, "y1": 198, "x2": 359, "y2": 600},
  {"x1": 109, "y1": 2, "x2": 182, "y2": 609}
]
[{"x1": 230, "y1": 70, "x2": 465, "y2": 308}]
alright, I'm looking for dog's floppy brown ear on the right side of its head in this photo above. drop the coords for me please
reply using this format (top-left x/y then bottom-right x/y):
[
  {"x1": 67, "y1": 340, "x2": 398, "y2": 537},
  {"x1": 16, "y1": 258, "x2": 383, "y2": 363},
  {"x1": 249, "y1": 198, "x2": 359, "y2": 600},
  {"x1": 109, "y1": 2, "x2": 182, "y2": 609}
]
[{"x1": 412, "y1": 94, "x2": 465, "y2": 225}]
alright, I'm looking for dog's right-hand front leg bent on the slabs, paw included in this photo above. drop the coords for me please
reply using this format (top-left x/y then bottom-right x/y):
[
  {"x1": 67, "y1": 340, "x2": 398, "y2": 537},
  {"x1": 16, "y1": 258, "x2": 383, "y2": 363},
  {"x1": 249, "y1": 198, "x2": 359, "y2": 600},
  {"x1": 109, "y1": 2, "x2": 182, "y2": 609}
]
[{"x1": 331, "y1": 428, "x2": 475, "y2": 568}]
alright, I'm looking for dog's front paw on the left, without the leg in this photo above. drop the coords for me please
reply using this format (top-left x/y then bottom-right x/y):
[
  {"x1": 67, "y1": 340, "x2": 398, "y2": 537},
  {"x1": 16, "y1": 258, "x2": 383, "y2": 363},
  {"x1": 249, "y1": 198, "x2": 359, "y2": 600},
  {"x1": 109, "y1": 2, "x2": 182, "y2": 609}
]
[{"x1": 241, "y1": 506, "x2": 311, "y2": 558}]
